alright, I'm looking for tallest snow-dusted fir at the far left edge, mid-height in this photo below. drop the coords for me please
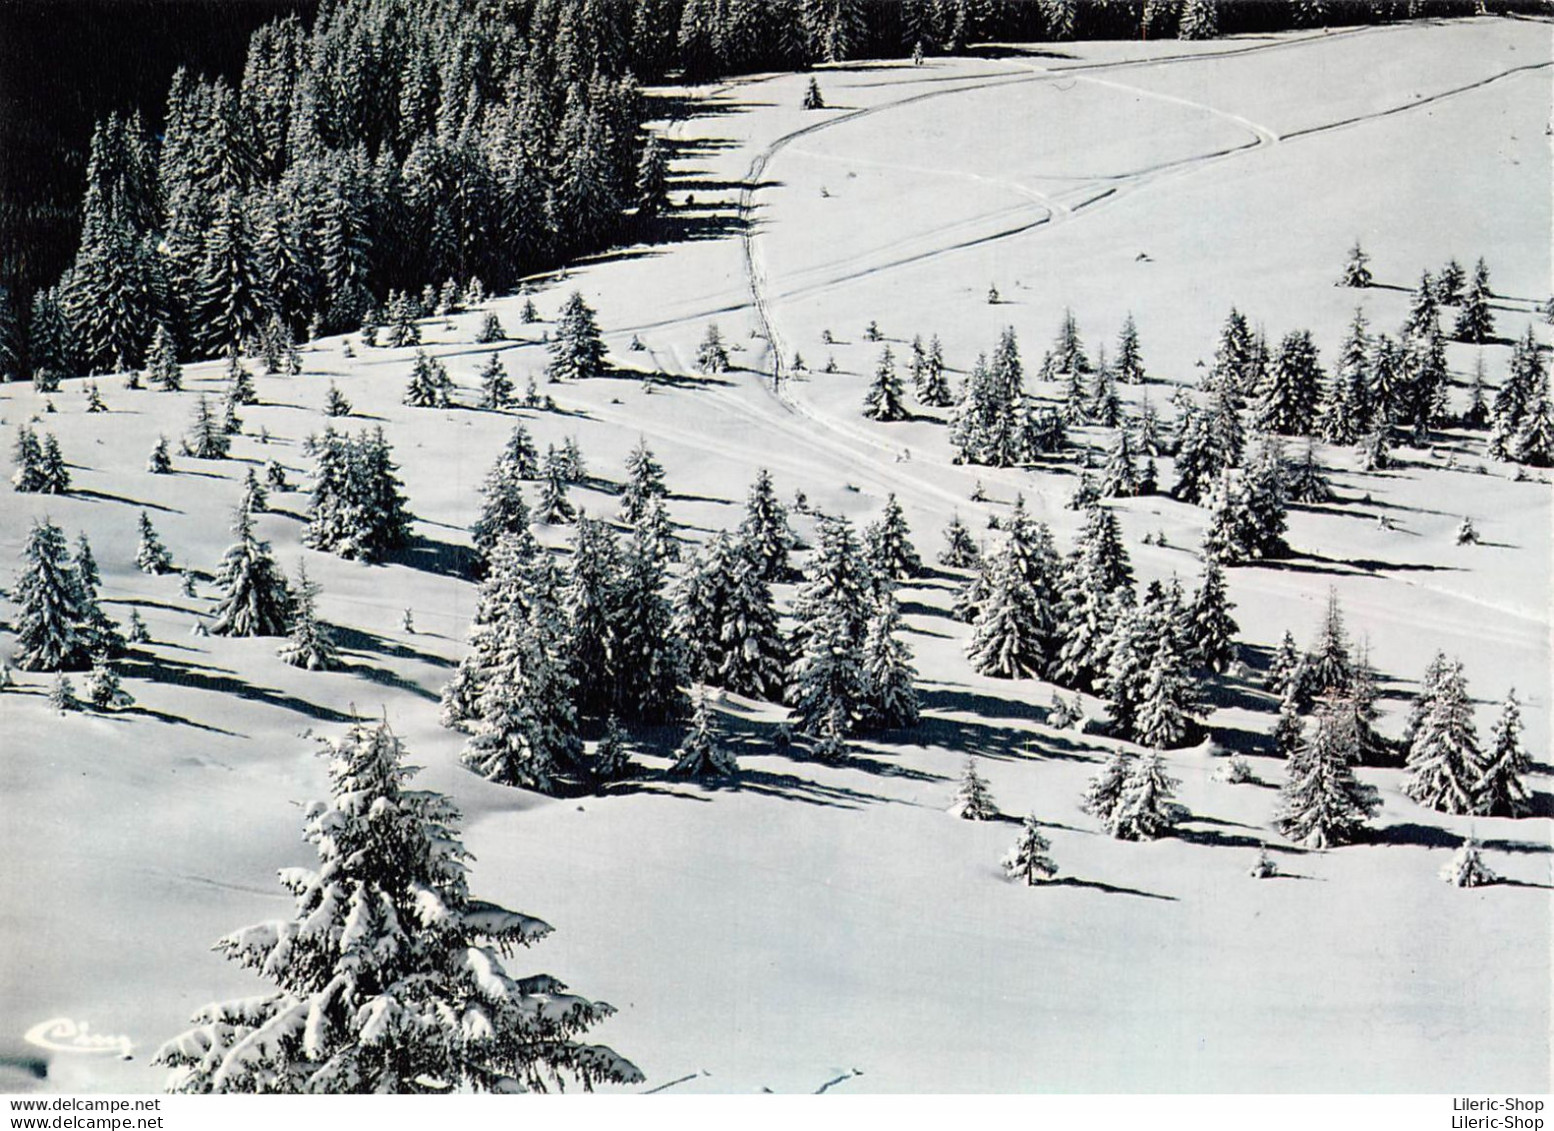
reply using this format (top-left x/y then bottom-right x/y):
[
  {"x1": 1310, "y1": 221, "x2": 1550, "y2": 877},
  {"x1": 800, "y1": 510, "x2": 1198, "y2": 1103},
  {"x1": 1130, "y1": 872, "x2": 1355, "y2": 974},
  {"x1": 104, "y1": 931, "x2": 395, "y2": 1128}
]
[{"x1": 12, "y1": 519, "x2": 92, "y2": 671}]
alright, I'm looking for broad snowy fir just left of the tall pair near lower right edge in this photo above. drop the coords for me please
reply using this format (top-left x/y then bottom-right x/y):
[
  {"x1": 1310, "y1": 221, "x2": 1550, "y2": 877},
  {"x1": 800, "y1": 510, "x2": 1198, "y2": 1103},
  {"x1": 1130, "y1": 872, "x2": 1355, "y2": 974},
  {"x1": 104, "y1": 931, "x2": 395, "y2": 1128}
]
[{"x1": 1274, "y1": 699, "x2": 1382, "y2": 848}]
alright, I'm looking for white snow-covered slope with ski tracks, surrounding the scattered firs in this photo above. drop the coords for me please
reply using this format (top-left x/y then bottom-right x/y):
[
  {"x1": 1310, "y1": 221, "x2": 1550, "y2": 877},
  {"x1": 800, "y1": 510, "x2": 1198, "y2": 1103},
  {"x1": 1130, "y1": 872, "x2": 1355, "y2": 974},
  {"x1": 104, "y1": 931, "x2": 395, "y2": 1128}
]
[{"x1": 0, "y1": 19, "x2": 1554, "y2": 1092}]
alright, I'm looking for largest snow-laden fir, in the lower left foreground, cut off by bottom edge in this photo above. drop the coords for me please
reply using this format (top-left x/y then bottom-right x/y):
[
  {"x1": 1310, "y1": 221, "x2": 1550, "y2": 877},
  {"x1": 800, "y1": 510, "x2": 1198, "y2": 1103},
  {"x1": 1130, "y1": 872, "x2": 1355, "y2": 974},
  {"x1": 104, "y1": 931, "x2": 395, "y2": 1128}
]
[{"x1": 155, "y1": 722, "x2": 642, "y2": 1094}]
